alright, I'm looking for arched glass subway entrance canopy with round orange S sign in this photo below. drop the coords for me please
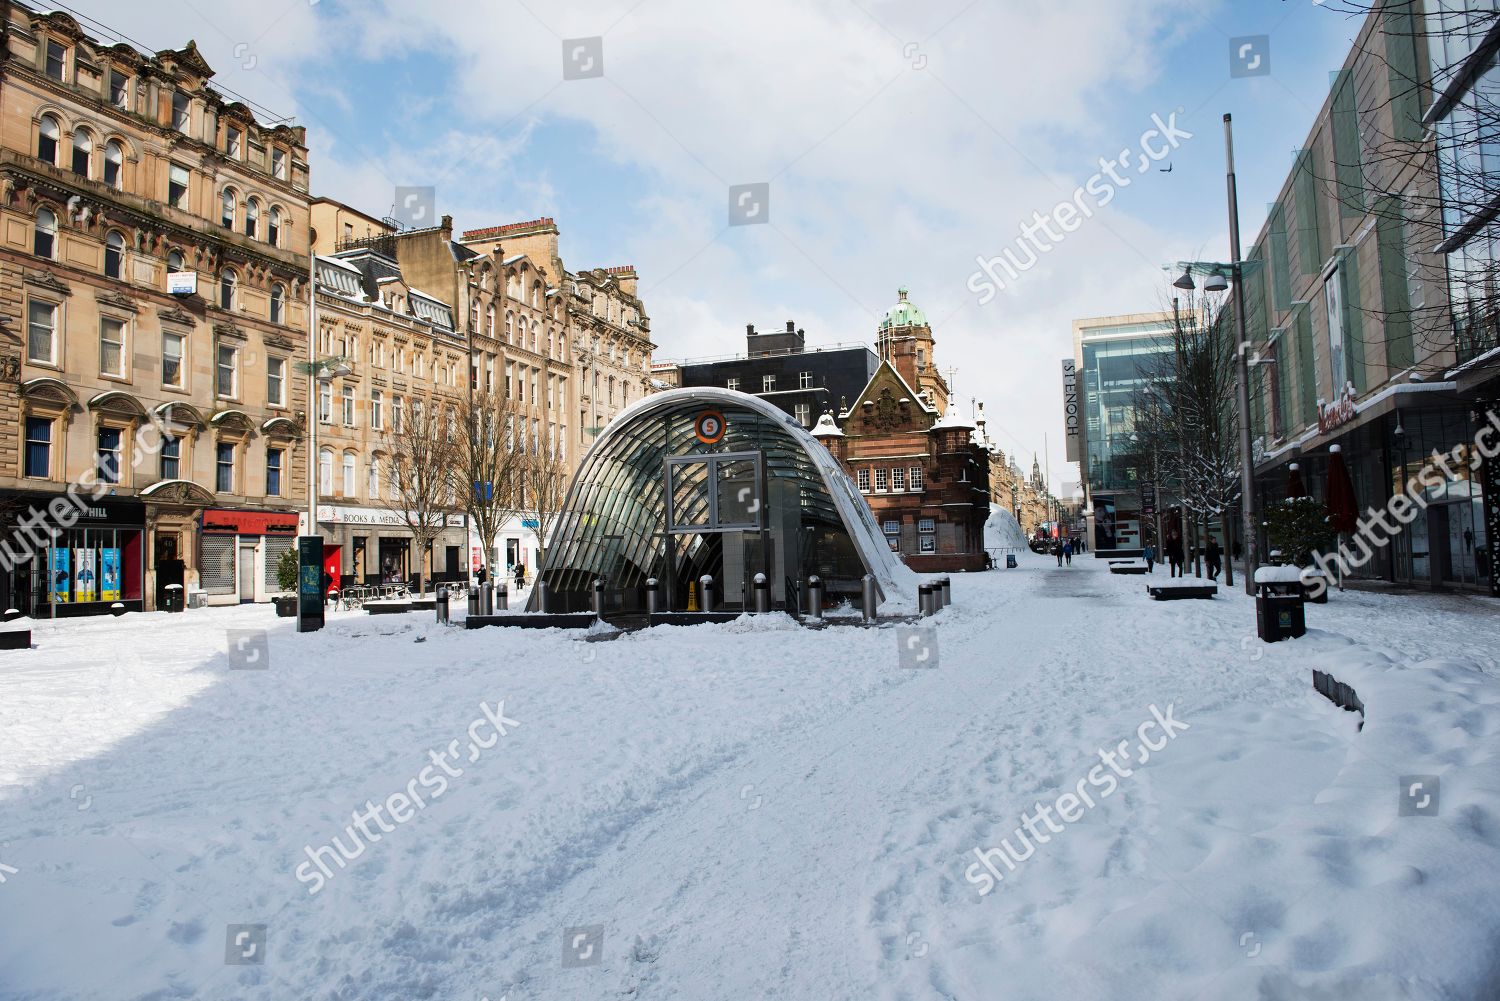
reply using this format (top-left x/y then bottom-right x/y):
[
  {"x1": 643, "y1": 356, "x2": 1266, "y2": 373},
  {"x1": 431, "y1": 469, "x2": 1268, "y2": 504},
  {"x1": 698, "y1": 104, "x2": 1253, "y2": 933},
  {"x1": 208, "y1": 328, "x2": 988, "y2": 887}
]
[{"x1": 533, "y1": 387, "x2": 917, "y2": 611}]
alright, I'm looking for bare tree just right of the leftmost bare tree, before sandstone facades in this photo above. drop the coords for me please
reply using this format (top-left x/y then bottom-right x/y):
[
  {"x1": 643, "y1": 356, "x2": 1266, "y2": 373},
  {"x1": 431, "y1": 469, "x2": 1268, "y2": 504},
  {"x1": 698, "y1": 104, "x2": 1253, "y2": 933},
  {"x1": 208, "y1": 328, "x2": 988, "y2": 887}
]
[{"x1": 458, "y1": 393, "x2": 528, "y2": 578}]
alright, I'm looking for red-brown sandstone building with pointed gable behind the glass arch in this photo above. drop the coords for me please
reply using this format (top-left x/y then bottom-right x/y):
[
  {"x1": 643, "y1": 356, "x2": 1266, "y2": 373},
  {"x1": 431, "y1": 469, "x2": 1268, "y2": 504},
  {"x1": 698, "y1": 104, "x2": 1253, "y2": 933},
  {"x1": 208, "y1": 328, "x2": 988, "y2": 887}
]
[{"x1": 813, "y1": 288, "x2": 990, "y2": 573}]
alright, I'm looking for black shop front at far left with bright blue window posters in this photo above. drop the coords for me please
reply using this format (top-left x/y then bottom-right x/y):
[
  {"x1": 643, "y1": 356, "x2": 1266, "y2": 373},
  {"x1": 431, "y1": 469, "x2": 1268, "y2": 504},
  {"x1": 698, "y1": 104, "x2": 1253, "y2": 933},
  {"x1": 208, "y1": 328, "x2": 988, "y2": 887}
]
[{"x1": 5, "y1": 494, "x2": 146, "y2": 617}]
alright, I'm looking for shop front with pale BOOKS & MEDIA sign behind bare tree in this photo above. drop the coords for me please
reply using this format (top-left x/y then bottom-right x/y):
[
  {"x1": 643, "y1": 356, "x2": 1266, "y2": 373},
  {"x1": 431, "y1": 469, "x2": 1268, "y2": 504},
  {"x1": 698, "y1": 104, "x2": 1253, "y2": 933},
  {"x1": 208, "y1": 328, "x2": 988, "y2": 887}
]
[{"x1": 318, "y1": 504, "x2": 468, "y2": 588}]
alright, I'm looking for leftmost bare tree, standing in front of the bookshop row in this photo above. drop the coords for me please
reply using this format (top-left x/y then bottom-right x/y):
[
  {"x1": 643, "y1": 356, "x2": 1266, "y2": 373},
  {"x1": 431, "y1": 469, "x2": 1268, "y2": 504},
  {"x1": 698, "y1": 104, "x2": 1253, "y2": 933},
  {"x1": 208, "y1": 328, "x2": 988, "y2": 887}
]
[{"x1": 386, "y1": 401, "x2": 462, "y2": 593}]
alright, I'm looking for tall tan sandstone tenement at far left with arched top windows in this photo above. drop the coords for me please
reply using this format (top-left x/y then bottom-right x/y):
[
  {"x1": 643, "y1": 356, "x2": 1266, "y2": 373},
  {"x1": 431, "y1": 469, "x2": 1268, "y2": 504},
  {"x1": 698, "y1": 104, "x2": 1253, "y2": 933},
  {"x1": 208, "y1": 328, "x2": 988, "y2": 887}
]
[{"x1": 0, "y1": 3, "x2": 308, "y2": 615}]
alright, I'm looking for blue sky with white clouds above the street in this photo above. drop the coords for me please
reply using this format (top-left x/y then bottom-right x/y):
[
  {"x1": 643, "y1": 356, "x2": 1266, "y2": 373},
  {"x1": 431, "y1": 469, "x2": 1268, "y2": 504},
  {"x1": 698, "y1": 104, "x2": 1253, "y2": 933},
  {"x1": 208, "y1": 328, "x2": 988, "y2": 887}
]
[{"x1": 87, "y1": 0, "x2": 1358, "y2": 483}]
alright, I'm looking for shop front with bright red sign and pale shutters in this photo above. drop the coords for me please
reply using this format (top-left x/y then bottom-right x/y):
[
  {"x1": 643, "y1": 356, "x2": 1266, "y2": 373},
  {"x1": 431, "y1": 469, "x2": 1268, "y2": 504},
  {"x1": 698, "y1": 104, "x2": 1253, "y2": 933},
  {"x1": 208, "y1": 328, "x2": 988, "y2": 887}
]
[{"x1": 198, "y1": 507, "x2": 297, "y2": 605}]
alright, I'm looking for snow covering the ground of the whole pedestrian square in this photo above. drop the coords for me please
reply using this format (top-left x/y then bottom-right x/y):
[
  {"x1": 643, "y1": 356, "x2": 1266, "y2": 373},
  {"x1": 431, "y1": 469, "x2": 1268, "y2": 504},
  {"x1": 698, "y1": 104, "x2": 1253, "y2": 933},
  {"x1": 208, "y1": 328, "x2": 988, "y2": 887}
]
[{"x1": 0, "y1": 554, "x2": 1500, "y2": 1001}]
